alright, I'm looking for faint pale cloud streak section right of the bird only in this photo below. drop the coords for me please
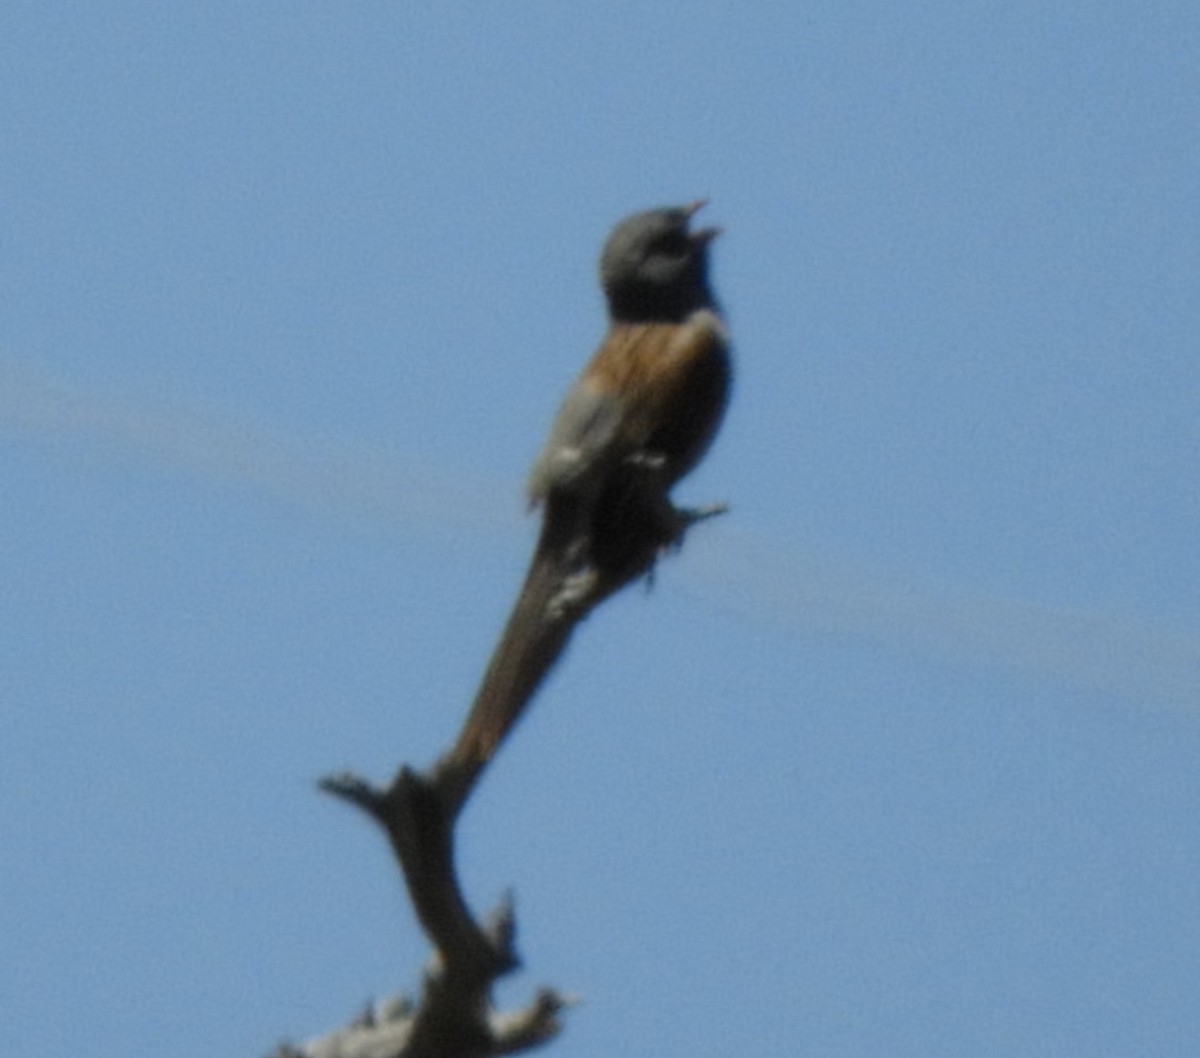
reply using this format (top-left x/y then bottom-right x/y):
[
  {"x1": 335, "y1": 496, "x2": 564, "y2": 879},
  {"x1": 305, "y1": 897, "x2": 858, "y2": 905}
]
[{"x1": 688, "y1": 527, "x2": 1200, "y2": 710}]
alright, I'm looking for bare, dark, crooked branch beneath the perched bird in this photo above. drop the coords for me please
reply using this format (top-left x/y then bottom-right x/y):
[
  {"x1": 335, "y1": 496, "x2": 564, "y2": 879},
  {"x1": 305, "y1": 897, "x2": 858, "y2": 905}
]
[{"x1": 282, "y1": 481, "x2": 725, "y2": 1058}]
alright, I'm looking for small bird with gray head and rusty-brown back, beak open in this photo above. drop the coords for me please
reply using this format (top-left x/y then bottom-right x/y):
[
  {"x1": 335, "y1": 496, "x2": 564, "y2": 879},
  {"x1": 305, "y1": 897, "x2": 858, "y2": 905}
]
[{"x1": 528, "y1": 199, "x2": 731, "y2": 523}]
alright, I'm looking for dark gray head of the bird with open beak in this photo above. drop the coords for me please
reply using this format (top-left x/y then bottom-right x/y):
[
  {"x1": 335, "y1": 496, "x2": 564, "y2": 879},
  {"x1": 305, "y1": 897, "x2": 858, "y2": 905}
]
[{"x1": 600, "y1": 199, "x2": 719, "y2": 323}]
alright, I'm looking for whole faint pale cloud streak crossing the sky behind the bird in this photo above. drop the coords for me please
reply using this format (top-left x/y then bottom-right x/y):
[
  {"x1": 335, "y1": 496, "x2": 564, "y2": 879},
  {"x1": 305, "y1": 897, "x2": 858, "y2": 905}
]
[{"x1": 0, "y1": 363, "x2": 1200, "y2": 709}]
